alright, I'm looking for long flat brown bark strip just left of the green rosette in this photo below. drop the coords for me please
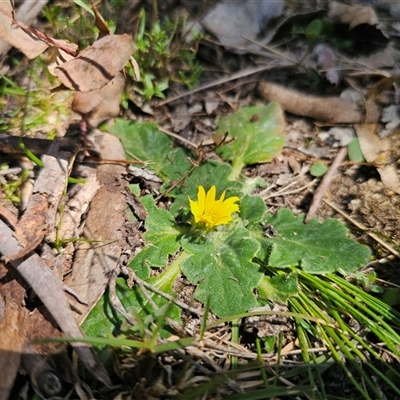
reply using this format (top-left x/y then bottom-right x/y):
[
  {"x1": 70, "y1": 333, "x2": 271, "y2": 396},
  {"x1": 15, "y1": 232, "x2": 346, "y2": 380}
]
[{"x1": 65, "y1": 133, "x2": 127, "y2": 323}]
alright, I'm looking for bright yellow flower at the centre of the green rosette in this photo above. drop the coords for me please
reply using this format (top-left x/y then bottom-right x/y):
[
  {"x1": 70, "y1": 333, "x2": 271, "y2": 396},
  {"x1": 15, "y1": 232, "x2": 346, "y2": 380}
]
[{"x1": 188, "y1": 186, "x2": 239, "y2": 229}]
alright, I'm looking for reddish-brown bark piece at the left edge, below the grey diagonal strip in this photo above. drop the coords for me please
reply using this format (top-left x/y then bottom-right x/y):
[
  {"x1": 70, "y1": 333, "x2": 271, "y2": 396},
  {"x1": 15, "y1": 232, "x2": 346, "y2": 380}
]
[{"x1": 0, "y1": 293, "x2": 28, "y2": 400}]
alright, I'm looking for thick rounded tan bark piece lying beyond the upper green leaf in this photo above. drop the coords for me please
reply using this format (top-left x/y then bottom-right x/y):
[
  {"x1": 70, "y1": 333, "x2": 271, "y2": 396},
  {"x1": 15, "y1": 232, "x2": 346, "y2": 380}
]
[{"x1": 258, "y1": 82, "x2": 370, "y2": 124}]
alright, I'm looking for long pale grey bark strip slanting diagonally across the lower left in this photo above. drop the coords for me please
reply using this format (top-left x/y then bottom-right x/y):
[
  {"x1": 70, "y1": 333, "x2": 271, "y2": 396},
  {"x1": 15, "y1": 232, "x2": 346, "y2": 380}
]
[{"x1": 0, "y1": 220, "x2": 110, "y2": 385}]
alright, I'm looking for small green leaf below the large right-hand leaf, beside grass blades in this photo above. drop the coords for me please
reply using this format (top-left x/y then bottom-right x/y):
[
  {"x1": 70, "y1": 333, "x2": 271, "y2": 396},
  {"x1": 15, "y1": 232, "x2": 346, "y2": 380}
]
[{"x1": 257, "y1": 273, "x2": 299, "y2": 304}]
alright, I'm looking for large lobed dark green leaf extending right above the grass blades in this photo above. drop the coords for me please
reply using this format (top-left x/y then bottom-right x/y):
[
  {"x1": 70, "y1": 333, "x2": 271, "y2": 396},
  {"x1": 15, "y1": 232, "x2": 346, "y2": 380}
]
[{"x1": 264, "y1": 209, "x2": 371, "y2": 275}]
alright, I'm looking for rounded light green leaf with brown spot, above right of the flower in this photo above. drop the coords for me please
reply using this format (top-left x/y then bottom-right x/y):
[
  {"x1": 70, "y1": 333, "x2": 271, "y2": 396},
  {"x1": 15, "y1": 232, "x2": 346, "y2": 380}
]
[{"x1": 216, "y1": 103, "x2": 285, "y2": 179}]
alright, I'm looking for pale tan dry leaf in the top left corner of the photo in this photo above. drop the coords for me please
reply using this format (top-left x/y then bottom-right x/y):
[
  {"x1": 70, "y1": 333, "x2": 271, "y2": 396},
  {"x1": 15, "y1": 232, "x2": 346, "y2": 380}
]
[{"x1": 0, "y1": 1, "x2": 48, "y2": 59}]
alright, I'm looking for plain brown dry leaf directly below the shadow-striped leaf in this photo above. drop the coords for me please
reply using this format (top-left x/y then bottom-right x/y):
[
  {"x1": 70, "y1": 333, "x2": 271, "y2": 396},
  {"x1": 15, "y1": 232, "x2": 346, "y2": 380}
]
[{"x1": 72, "y1": 73, "x2": 125, "y2": 128}]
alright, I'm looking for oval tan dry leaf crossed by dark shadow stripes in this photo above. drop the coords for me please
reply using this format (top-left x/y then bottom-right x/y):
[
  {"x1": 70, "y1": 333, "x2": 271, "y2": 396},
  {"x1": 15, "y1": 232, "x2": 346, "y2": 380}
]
[{"x1": 54, "y1": 34, "x2": 135, "y2": 92}]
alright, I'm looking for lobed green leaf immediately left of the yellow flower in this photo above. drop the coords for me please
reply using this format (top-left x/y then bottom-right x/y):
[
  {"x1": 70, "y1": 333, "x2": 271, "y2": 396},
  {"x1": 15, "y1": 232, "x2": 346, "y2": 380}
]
[{"x1": 129, "y1": 195, "x2": 188, "y2": 278}]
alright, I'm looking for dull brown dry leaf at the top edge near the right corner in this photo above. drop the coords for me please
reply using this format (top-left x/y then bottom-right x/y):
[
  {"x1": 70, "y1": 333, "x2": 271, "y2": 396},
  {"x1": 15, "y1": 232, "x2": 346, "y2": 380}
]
[{"x1": 328, "y1": 1, "x2": 378, "y2": 29}]
